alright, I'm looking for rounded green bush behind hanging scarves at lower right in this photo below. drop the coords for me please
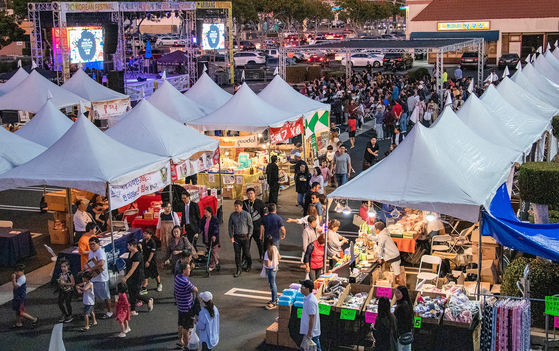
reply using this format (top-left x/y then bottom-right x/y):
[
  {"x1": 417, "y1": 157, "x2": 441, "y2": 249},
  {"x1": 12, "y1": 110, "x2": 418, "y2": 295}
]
[{"x1": 501, "y1": 257, "x2": 559, "y2": 328}]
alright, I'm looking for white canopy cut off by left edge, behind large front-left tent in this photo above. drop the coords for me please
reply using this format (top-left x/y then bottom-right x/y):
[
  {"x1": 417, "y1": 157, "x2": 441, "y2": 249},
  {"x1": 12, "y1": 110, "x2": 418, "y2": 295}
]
[{"x1": 0, "y1": 127, "x2": 47, "y2": 174}]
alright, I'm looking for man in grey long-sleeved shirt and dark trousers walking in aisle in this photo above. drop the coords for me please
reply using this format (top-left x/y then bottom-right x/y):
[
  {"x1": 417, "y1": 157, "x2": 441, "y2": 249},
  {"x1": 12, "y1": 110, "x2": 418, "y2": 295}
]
[{"x1": 229, "y1": 200, "x2": 253, "y2": 278}]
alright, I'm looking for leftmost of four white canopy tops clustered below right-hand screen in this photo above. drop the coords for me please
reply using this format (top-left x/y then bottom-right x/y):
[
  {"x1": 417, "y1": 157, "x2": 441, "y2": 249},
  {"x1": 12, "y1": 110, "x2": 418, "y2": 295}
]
[{"x1": 148, "y1": 80, "x2": 206, "y2": 123}]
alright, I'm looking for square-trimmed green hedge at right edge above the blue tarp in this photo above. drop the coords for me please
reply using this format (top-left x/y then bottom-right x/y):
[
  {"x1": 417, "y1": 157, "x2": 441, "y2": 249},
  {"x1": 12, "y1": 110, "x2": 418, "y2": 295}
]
[{"x1": 518, "y1": 162, "x2": 559, "y2": 206}]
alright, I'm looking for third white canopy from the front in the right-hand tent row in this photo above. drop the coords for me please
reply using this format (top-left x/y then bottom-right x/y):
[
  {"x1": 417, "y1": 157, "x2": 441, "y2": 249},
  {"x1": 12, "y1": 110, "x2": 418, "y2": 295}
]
[{"x1": 456, "y1": 94, "x2": 527, "y2": 152}]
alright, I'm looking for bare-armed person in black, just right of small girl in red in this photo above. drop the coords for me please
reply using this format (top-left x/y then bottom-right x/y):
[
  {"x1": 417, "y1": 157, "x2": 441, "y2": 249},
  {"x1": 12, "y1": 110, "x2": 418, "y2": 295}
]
[{"x1": 122, "y1": 239, "x2": 153, "y2": 316}]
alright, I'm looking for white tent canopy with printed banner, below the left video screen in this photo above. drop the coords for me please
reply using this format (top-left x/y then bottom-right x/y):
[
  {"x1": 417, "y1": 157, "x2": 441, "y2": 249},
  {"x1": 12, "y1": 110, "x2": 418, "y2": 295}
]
[{"x1": 61, "y1": 68, "x2": 130, "y2": 120}]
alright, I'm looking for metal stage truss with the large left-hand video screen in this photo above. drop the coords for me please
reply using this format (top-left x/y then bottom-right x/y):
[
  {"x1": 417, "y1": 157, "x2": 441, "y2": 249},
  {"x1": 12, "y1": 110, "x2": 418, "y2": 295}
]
[{"x1": 27, "y1": 2, "x2": 199, "y2": 82}]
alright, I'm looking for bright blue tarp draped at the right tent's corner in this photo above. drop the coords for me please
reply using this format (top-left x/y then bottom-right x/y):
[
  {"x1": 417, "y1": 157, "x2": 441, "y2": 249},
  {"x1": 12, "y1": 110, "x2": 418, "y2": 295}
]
[{"x1": 482, "y1": 184, "x2": 559, "y2": 261}]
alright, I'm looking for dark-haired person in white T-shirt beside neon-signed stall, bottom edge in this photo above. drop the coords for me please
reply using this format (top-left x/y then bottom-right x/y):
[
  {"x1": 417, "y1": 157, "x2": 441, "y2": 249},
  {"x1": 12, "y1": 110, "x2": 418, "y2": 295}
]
[{"x1": 299, "y1": 279, "x2": 322, "y2": 351}]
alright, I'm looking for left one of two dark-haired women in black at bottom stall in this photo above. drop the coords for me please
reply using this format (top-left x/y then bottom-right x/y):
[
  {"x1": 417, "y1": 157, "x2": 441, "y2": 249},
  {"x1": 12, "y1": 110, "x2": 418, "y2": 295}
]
[{"x1": 371, "y1": 296, "x2": 398, "y2": 351}]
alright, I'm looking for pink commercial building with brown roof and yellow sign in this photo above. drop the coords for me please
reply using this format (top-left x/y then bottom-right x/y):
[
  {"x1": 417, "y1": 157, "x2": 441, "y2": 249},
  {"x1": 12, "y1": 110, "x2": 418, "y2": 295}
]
[{"x1": 406, "y1": 0, "x2": 559, "y2": 63}]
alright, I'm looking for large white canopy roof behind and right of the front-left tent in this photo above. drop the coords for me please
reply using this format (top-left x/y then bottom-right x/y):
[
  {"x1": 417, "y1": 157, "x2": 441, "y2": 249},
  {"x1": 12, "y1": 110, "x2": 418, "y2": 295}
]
[{"x1": 105, "y1": 100, "x2": 219, "y2": 163}]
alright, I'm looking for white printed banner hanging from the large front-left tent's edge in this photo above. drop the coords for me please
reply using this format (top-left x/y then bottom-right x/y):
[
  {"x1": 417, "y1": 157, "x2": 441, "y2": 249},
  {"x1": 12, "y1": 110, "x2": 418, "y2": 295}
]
[{"x1": 110, "y1": 165, "x2": 171, "y2": 210}]
